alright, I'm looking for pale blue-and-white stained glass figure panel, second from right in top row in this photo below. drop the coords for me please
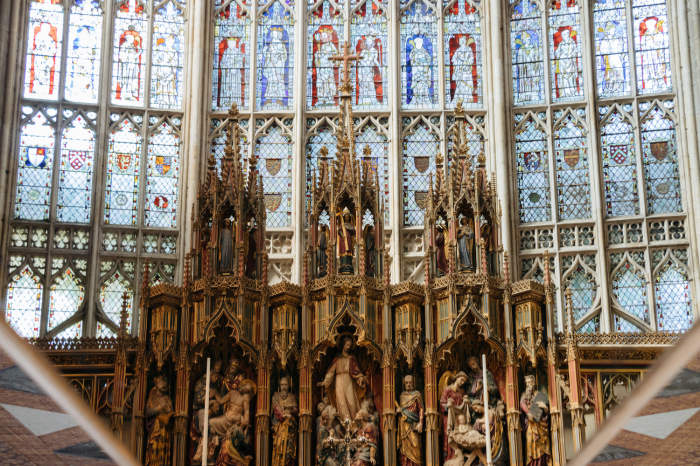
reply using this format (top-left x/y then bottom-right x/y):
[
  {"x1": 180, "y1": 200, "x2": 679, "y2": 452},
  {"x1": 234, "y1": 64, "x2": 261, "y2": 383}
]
[{"x1": 593, "y1": 0, "x2": 630, "y2": 97}]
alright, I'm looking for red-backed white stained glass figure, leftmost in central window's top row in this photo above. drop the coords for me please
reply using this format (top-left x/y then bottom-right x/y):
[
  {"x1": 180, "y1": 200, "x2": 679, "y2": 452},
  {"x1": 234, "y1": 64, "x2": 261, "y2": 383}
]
[{"x1": 211, "y1": 0, "x2": 250, "y2": 110}]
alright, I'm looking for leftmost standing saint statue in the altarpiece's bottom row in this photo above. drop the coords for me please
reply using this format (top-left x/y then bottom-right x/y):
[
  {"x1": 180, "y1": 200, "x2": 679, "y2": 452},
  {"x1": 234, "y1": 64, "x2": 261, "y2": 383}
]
[{"x1": 144, "y1": 375, "x2": 175, "y2": 466}]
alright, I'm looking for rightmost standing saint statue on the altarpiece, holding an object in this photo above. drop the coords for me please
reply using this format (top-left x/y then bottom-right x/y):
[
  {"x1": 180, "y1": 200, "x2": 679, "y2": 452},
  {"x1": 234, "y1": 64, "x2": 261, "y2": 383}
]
[{"x1": 520, "y1": 375, "x2": 552, "y2": 466}]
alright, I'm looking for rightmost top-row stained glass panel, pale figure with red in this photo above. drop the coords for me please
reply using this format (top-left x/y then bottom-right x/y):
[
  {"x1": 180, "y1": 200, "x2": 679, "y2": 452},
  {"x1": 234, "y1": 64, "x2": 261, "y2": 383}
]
[{"x1": 633, "y1": 0, "x2": 672, "y2": 94}]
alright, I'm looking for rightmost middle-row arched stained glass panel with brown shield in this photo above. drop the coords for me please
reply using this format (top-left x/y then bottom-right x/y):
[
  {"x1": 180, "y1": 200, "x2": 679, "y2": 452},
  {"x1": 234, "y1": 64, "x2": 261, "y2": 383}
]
[{"x1": 641, "y1": 107, "x2": 683, "y2": 214}]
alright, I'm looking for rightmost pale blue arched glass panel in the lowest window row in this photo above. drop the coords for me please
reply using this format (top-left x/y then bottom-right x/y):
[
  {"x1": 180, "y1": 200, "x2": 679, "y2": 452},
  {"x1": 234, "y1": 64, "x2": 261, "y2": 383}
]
[{"x1": 654, "y1": 259, "x2": 693, "y2": 331}]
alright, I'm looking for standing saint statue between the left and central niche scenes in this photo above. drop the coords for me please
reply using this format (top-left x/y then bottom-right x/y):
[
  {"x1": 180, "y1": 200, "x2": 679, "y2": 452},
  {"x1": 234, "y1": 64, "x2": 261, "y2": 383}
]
[{"x1": 272, "y1": 377, "x2": 299, "y2": 466}]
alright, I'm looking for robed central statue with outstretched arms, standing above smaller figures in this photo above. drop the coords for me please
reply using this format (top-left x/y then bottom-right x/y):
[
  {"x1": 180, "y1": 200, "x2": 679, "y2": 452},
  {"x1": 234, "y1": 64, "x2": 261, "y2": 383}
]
[{"x1": 318, "y1": 337, "x2": 365, "y2": 419}]
